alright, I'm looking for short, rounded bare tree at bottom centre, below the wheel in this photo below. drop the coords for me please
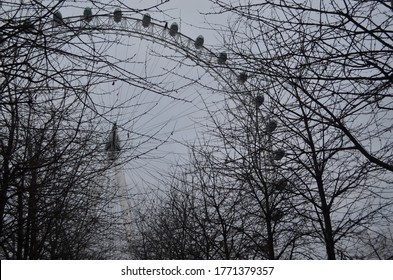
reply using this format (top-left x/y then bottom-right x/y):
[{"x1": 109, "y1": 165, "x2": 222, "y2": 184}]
[{"x1": 132, "y1": 160, "x2": 245, "y2": 259}]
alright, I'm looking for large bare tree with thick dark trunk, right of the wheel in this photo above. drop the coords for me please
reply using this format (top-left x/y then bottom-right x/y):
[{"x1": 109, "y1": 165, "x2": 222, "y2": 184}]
[{"x1": 199, "y1": 1, "x2": 392, "y2": 259}]
